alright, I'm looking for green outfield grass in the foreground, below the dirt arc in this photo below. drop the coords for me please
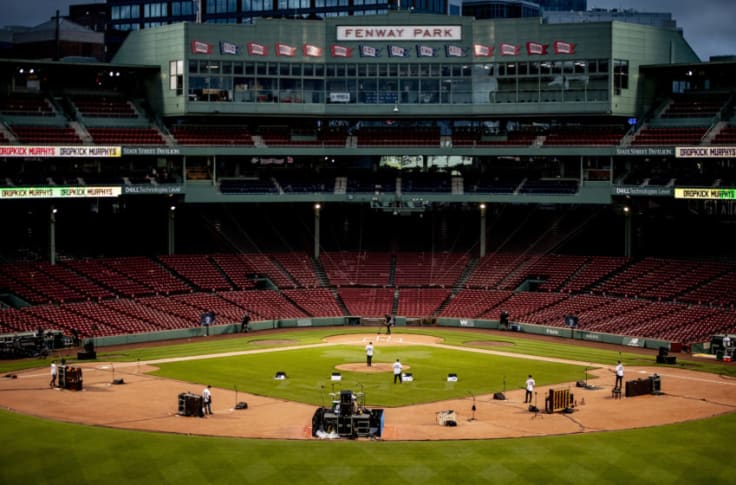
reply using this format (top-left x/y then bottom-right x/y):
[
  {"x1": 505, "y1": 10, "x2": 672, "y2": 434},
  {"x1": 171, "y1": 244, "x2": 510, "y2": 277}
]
[{"x1": 0, "y1": 411, "x2": 736, "y2": 485}]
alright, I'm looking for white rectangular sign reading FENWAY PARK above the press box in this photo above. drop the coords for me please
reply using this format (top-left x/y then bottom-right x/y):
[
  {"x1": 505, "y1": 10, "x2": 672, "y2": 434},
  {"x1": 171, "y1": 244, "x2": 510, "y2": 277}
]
[{"x1": 337, "y1": 25, "x2": 463, "y2": 42}]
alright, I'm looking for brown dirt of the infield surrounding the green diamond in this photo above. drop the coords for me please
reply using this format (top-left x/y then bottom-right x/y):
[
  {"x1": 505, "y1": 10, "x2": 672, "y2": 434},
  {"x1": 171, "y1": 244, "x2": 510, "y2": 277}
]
[{"x1": 0, "y1": 333, "x2": 736, "y2": 441}]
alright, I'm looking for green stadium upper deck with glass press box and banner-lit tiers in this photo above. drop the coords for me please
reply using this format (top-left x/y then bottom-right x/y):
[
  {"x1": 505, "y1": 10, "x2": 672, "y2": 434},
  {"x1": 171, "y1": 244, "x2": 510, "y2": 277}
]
[{"x1": 0, "y1": 12, "x2": 736, "y2": 251}]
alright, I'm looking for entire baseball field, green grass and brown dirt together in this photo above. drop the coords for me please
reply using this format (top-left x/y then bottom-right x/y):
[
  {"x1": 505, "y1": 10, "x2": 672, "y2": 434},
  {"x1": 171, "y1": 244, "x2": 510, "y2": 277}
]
[{"x1": 0, "y1": 327, "x2": 736, "y2": 484}]
